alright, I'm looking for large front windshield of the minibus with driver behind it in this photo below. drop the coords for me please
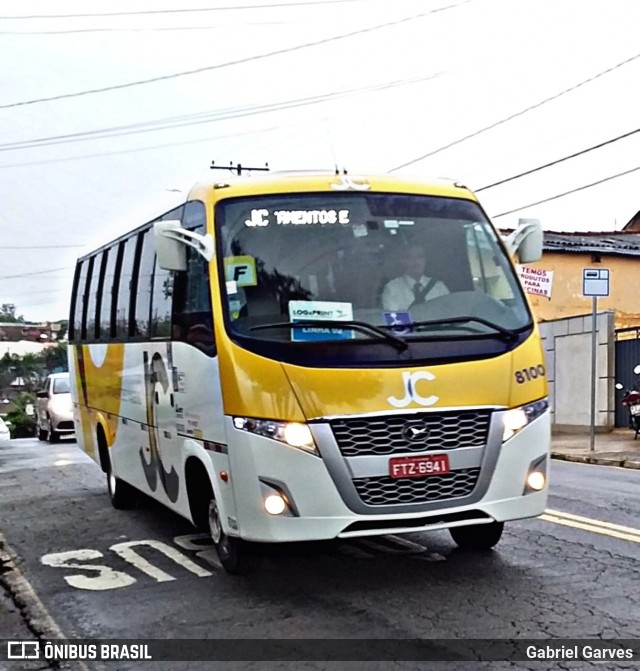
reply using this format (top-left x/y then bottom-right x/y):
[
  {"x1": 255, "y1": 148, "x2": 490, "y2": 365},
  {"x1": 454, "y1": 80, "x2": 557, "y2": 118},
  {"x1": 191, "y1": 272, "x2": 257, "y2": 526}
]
[{"x1": 215, "y1": 192, "x2": 531, "y2": 349}]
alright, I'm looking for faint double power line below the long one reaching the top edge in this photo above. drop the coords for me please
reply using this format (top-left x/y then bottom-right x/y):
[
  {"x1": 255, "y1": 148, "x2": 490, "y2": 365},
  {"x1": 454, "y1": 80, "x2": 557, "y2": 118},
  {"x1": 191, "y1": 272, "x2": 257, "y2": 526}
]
[{"x1": 0, "y1": 72, "x2": 443, "y2": 152}]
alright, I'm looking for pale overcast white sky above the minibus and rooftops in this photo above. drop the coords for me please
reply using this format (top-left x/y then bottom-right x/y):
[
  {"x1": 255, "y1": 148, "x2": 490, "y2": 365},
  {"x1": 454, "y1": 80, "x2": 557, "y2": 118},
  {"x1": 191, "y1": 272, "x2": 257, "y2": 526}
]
[{"x1": 0, "y1": 0, "x2": 640, "y2": 321}]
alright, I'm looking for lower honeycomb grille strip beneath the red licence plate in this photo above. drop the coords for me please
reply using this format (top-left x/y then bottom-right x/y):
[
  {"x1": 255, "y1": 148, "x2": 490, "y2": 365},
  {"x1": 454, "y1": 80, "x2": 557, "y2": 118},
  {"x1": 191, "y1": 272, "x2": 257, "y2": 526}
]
[{"x1": 353, "y1": 468, "x2": 480, "y2": 506}]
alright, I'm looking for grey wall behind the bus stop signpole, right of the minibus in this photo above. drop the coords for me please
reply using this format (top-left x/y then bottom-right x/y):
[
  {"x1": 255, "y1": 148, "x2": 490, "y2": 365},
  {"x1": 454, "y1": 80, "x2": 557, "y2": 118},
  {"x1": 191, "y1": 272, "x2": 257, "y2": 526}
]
[{"x1": 540, "y1": 314, "x2": 615, "y2": 431}]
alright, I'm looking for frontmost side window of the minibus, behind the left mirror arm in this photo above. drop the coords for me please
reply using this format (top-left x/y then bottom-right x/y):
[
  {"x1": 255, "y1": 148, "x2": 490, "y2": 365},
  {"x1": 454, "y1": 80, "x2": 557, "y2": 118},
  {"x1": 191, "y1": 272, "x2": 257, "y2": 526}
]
[{"x1": 173, "y1": 201, "x2": 216, "y2": 356}]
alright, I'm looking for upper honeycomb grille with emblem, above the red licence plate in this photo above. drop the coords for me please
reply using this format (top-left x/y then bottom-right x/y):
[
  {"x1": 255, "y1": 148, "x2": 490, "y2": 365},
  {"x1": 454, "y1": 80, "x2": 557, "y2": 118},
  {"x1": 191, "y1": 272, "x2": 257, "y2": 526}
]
[{"x1": 331, "y1": 409, "x2": 491, "y2": 457}]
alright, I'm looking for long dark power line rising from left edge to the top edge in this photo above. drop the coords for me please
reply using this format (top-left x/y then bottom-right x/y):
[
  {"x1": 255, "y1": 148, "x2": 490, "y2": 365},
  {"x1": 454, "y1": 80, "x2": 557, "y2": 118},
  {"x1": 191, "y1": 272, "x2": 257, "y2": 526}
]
[{"x1": 0, "y1": 0, "x2": 473, "y2": 109}]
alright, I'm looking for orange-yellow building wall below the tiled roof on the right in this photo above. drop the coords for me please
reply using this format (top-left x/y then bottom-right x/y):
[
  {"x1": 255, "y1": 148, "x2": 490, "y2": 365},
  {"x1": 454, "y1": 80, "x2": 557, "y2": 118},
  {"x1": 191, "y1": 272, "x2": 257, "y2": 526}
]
[{"x1": 527, "y1": 251, "x2": 640, "y2": 328}]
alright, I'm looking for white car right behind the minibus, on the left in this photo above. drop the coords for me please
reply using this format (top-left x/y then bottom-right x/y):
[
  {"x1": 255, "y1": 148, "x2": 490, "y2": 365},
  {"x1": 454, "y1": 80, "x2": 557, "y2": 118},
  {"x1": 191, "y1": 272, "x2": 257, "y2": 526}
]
[{"x1": 36, "y1": 373, "x2": 75, "y2": 443}]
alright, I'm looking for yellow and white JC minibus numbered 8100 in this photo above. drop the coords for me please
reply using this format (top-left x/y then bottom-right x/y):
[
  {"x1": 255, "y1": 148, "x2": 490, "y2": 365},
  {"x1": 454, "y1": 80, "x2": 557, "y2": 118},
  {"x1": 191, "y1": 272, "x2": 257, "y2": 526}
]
[{"x1": 69, "y1": 172, "x2": 550, "y2": 573}]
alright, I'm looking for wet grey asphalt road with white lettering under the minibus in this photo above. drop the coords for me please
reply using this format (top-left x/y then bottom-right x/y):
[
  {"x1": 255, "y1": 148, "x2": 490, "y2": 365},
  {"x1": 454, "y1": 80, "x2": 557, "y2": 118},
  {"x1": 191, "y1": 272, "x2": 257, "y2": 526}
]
[{"x1": 0, "y1": 440, "x2": 640, "y2": 671}]
